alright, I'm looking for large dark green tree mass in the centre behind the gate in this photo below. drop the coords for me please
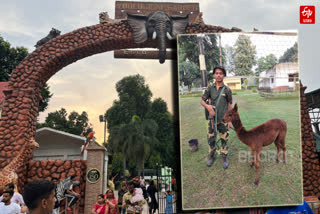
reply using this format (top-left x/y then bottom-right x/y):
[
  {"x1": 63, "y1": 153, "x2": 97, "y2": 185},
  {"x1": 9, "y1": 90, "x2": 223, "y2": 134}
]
[{"x1": 106, "y1": 75, "x2": 175, "y2": 173}]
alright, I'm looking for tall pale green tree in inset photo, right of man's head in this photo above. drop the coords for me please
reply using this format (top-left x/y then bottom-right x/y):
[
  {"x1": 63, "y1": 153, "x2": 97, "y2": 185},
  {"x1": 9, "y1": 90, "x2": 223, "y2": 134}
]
[{"x1": 234, "y1": 35, "x2": 257, "y2": 76}]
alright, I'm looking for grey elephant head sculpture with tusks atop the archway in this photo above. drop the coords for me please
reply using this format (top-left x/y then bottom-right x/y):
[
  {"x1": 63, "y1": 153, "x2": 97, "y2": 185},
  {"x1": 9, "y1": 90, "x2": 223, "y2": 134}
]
[{"x1": 127, "y1": 11, "x2": 189, "y2": 64}]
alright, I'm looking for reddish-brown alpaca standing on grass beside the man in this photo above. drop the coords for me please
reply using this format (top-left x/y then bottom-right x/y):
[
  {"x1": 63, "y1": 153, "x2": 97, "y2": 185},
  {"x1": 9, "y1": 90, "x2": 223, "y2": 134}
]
[{"x1": 224, "y1": 104, "x2": 287, "y2": 185}]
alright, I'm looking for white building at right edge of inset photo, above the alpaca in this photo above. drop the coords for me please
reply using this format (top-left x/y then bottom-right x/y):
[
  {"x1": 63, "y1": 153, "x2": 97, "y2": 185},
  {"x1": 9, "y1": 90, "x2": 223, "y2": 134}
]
[{"x1": 259, "y1": 62, "x2": 299, "y2": 91}]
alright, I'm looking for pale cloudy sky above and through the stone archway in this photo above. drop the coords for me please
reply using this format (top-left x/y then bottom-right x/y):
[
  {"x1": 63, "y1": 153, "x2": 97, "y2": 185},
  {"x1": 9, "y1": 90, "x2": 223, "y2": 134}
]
[{"x1": 0, "y1": 0, "x2": 320, "y2": 142}]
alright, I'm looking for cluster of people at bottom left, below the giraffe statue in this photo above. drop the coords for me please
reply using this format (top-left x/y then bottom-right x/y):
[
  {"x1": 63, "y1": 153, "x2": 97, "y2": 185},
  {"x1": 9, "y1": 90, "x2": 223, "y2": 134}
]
[{"x1": 0, "y1": 175, "x2": 80, "y2": 214}]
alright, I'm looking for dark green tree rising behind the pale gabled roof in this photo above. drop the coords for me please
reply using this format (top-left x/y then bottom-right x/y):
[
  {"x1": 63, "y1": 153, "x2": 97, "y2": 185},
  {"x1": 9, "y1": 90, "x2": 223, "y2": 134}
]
[{"x1": 37, "y1": 108, "x2": 93, "y2": 137}]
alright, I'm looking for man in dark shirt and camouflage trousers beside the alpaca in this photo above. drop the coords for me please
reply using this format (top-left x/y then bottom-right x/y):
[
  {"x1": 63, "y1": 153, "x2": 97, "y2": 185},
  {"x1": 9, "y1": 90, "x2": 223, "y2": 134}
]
[{"x1": 201, "y1": 66, "x2": 232, "y2": 169}]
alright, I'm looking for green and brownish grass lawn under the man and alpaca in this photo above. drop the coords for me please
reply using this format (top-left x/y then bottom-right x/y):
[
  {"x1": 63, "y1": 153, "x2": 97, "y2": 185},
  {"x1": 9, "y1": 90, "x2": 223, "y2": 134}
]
[{"x1": 180, "y1": 91, "x2": 302, "y2": 209}]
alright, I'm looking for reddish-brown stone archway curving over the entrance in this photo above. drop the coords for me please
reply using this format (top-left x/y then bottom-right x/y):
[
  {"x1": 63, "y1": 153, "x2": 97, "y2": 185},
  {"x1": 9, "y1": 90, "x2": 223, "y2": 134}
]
[{"x1": 0, "y1": 20, "x2": 231, "y2": 186}]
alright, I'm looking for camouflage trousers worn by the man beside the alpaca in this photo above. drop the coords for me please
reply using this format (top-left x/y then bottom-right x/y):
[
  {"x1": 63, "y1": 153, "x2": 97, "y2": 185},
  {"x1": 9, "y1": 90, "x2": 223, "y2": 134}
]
[{"x1": 208, "y1": 118, "x2": 229, "y2": 155}]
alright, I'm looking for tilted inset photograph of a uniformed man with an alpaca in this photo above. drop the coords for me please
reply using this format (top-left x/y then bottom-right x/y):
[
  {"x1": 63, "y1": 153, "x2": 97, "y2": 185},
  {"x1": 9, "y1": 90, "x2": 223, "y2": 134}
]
[{"x1": 178, "y1": 32, "x2": 303, "y2": 210}]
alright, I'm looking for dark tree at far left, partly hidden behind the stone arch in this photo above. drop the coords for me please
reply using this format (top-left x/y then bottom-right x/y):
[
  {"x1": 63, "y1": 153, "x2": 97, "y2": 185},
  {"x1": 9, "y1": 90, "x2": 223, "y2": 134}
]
[{"x1": 0, "y1": 36, "x2": 52, "y2": 112}]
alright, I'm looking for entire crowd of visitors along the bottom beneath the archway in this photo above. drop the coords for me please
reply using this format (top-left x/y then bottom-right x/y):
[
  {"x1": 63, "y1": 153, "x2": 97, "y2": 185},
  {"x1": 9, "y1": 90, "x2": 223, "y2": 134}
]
[{"x1": 0, "y1": 175, "x2": 174, "y2": 214}]
